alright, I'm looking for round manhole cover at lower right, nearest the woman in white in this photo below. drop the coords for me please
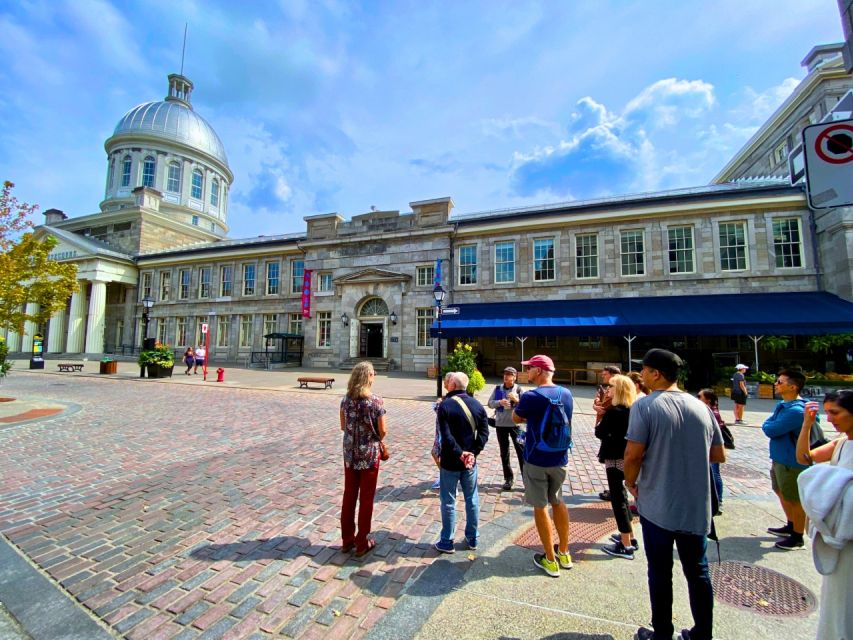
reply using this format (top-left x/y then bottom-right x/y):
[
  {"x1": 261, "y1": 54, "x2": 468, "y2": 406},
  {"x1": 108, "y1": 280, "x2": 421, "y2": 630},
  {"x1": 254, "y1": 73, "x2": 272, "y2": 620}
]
[{"x1": 709, "y1": 562, "x2": 817, "y2": 616}]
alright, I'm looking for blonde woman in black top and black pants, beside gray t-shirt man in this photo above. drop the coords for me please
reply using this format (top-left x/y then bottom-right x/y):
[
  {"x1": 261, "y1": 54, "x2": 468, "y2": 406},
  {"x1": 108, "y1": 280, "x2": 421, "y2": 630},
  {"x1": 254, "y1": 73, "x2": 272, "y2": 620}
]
[{"x1": 595, "y1": 375, "x2": 638, "y2": 560}]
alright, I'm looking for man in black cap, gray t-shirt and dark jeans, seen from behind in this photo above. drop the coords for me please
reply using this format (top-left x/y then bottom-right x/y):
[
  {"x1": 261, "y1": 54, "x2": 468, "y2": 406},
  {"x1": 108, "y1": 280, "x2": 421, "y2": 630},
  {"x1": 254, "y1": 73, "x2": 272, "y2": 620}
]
[{"x1": 625, "y1": 349, "x2": 726, "y2": 640}]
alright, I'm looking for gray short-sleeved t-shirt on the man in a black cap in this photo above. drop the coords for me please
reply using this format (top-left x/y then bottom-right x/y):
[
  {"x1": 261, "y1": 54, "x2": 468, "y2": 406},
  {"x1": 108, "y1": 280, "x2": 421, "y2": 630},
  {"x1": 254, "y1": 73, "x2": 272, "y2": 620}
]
[{"x1": 625, "y1": 391, "x2": 723, "y2": 535}]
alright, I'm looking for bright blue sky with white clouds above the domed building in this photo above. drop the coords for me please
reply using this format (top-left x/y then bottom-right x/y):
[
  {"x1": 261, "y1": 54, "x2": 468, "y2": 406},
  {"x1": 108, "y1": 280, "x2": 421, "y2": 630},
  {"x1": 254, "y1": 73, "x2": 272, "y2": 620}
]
[{"x1": 0, "y1": 0, "x2": 842, "y2": 238}]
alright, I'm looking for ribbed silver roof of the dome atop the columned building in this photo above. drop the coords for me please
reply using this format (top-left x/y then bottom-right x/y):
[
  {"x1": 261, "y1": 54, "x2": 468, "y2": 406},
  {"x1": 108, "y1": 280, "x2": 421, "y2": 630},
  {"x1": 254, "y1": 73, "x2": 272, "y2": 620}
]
[{"x1": 113, "y1": 100, "x2": 228, "y2": 167}]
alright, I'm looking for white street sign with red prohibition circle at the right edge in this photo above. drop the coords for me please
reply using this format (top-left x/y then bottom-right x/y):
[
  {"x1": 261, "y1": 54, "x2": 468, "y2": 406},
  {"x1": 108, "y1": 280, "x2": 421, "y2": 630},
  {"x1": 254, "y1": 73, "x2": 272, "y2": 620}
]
[{"x1": 803, "y1": 120, "x2": 853, "y2": 209}]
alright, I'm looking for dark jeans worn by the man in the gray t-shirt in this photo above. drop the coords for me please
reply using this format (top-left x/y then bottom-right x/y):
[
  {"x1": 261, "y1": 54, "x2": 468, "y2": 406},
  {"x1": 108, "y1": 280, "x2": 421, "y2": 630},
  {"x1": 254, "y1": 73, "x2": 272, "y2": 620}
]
[{"x1": 640, "y1": 516, "x2": 714, "y2": 640}]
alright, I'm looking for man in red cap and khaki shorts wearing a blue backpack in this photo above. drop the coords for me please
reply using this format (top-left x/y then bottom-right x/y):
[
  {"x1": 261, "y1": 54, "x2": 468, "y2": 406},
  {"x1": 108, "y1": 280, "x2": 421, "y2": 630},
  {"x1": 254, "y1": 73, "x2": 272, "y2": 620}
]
[{"x1": 512, "y1": 355, "x2": 574, "y2": 578}]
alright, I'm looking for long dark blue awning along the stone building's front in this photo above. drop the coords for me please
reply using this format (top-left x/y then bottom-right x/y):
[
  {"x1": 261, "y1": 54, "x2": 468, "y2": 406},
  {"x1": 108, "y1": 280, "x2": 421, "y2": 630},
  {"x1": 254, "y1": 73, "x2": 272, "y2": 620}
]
[{"x1": 430, "y1": 291, "x2": 853, "y2": 338}]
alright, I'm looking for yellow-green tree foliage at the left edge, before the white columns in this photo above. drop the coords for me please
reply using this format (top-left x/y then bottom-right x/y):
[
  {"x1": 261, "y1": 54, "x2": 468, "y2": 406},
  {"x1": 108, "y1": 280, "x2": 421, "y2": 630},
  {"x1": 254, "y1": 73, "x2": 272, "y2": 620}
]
[{"x1": 0, "y1": 181, "x2": 77, "y2": 333}]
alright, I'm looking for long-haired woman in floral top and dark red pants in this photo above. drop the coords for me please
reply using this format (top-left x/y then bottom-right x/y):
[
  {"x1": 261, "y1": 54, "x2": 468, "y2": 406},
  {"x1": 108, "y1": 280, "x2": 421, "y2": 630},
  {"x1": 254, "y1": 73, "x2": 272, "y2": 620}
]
[{"x1": 341, "y1": 362, "x2": 385, "y2": 558}]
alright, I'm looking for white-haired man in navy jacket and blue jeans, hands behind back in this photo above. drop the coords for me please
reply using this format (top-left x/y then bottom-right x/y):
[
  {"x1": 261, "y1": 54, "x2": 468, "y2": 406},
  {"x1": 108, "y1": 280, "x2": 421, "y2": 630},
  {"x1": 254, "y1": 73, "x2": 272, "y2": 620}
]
[{"x1": 433, "y1": 371, "x2": 489, "y2": 553}]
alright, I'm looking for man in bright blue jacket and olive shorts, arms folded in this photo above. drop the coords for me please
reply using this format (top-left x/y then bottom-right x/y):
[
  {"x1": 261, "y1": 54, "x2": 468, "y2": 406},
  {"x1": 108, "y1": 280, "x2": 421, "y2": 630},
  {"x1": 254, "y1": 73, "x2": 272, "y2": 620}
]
[{"x1": 761, "y1": 369, "x2": 807, "y2": 551}]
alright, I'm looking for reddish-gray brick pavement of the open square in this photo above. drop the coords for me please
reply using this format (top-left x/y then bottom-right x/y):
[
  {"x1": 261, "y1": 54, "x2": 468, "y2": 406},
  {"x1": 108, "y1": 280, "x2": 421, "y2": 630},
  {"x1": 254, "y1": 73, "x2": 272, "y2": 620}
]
[{"x1": 0, "y1": 374, "x2": 784, "y2": 640}]
